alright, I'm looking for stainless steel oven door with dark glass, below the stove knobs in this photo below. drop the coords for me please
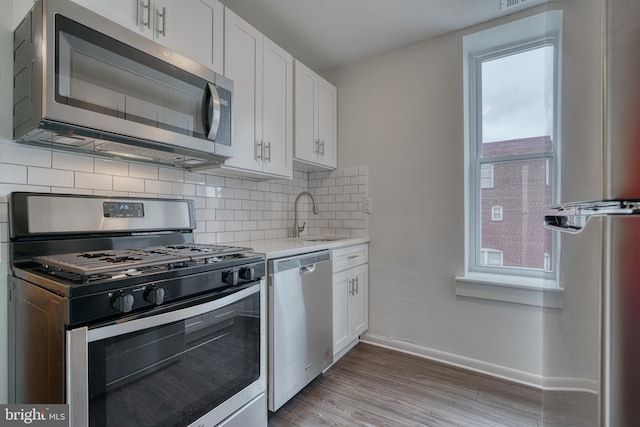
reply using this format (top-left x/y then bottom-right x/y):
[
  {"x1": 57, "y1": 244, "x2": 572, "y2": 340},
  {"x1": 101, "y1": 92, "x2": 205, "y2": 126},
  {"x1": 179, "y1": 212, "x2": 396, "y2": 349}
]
[{"x1": 67, "y1": 280, "x2": 266, "y2": 427}]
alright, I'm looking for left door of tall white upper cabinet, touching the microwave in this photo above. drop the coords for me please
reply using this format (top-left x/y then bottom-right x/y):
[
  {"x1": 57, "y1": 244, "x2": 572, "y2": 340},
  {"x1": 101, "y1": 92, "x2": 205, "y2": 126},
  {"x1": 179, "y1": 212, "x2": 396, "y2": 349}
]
[{"x1": 224, "y1": 9, "x2": 263, "y2": 171}]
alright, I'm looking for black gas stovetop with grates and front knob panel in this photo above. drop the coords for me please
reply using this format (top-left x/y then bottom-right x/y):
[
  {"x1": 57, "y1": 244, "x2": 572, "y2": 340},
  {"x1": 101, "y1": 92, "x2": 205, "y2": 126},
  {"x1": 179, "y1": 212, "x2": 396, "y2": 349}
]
[{"x1": 13, "y1": 243, "x2": 266, "y2": 325}]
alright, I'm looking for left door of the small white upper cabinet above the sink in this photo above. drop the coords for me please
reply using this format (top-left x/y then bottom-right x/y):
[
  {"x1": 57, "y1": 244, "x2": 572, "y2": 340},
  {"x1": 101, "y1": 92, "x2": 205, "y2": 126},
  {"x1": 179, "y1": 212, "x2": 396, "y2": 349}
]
[{"x1": 294, "y1": 61, "x2": 318, "y2": 163}]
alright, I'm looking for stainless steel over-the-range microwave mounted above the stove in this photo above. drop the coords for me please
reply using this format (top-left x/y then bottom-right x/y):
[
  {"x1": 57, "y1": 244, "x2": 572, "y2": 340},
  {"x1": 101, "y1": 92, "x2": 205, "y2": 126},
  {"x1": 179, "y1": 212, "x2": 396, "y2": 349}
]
[{"x1": 13, "y1": 0, "x2": 233, "y2": 169}]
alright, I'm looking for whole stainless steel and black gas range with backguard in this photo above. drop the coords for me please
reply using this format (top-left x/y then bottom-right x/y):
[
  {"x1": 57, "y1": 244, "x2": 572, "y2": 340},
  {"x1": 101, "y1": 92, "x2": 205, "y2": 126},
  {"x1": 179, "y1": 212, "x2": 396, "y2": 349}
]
[{"x1": 9, "y1": 193, "x2": 267, "y2": 427}]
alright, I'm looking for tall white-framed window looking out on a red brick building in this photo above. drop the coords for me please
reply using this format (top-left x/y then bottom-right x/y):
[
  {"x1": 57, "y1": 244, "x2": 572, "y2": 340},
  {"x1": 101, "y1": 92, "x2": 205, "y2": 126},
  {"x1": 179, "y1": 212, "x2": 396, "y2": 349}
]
[{"x1": 460, "y1": 11, "x2": 562, "y2": 304}]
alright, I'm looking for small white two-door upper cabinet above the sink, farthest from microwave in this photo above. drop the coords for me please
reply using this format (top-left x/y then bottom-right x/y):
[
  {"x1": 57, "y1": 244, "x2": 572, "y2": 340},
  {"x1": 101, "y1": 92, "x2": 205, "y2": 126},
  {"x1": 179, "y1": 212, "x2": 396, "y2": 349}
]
[{"x1": 294, "y1": 60, "x2": 338, "y2": 169}]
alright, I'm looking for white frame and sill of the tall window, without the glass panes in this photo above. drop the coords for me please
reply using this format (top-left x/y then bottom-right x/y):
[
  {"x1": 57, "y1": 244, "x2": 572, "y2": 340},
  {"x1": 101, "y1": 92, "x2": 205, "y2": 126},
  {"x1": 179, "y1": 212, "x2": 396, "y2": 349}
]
[{"x1": 456, "y1": 10, "x2": 562, "y2": 307}]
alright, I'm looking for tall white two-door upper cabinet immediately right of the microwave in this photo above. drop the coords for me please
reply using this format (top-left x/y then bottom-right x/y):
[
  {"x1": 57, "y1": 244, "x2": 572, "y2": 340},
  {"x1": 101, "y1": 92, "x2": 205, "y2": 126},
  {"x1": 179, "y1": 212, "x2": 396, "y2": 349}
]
[{"x1": 221, "y1": 9, "x2": 293, "y2": 178}]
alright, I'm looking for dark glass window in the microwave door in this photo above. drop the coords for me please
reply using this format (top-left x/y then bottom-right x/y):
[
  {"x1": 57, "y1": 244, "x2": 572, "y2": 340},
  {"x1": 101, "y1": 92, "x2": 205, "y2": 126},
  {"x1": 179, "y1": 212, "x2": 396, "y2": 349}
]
[{"x1": 56, "y1": 15, "x2": 206, "y2": 139}]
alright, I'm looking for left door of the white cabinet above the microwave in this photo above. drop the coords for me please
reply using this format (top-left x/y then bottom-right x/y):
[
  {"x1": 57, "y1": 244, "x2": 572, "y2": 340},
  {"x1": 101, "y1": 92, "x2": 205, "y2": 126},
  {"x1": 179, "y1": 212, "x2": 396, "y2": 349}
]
[{"x1": 73, "y1": 0, "x2": 154, "y2": 38}]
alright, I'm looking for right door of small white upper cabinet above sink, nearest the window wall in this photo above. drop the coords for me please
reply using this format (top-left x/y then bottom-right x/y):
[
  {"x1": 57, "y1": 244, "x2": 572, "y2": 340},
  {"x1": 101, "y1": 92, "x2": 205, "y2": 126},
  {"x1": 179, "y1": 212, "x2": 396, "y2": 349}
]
[{"x1": 318, "y1": 78, "x2": 338, "y2": 168}]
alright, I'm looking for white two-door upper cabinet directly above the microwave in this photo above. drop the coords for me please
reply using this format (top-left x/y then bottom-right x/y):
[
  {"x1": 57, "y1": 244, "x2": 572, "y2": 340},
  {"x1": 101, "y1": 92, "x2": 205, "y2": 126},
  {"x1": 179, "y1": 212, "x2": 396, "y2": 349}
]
[{"x1": 73, "y1": 0, "x2": 224, "y2": 73}]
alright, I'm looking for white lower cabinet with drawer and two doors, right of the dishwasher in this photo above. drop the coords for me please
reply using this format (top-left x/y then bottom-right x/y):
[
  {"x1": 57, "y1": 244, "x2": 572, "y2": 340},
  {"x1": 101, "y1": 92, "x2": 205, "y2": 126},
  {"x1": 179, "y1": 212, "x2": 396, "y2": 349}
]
[{"x1": 333, "y1": 244, "x2": 369, "y2": 361}]
